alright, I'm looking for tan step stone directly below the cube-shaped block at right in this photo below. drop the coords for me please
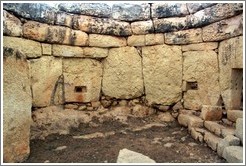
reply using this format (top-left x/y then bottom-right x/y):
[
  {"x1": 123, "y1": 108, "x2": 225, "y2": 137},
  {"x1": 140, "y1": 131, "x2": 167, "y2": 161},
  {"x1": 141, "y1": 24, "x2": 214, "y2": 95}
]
[{"x1": 204, "y1": 121, "x2": 235, "y2": 138}]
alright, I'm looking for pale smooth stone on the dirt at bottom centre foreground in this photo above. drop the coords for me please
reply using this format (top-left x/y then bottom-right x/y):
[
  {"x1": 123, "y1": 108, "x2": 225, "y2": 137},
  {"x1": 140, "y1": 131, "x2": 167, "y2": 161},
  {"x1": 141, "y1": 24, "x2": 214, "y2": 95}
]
[{"x1": 117, "y1": 149, "x2": 155, "y2": 163}]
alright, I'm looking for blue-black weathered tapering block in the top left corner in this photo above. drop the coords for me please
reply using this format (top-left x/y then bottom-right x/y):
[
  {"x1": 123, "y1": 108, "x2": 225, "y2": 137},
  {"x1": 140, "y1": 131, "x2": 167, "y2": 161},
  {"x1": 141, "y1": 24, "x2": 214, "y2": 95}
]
[{"x1": 3, "y1": 3, "x2": 55, "y2": 24}]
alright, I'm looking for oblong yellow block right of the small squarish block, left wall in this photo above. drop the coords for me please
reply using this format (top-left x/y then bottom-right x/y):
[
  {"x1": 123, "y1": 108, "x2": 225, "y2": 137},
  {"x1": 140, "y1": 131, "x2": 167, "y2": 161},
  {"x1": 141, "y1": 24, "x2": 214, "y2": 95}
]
[{"x1": 53, "y1": 44, "x2": 84, "y2": 57}]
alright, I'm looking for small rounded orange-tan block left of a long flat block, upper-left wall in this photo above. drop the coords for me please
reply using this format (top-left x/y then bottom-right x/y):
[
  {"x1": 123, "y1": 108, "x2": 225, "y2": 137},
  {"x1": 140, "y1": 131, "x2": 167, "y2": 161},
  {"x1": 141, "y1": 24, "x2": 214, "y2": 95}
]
[{"x1": 71, "y1": 30, "x2": 89, "y2": 46}]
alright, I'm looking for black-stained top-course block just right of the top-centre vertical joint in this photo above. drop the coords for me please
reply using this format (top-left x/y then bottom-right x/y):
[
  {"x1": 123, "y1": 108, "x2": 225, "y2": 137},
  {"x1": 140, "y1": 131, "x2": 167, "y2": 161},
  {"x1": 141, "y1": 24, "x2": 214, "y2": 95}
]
[{"x1": 151, "y1": 3, "x2": 189, "y2": 18}]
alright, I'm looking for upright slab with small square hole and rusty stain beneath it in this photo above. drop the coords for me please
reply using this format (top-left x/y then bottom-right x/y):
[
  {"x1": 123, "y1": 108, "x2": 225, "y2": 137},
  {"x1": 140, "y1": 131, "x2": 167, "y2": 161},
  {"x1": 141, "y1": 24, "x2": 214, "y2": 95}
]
[{"x1": 63, "y1": 58, "x2": 102, "y2": 102}]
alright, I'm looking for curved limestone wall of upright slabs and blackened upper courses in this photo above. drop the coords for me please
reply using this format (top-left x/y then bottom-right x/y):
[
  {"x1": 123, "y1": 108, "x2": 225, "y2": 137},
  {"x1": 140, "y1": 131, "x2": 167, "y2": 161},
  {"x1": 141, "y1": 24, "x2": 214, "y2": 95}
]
[{"x1": 3, "y1": 2, "x2": 243, "y2": 161}]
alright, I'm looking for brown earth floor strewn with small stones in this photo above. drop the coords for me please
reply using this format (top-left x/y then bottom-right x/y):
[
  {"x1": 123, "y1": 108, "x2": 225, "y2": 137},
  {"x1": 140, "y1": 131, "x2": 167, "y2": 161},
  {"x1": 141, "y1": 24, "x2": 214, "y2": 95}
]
[{"x1": 25, "y1": 116, "x2": 226, "y2": 163}]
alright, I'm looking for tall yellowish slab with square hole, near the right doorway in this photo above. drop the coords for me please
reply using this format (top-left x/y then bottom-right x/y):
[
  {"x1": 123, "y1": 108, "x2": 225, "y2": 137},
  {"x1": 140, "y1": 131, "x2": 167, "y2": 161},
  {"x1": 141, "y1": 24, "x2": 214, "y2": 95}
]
[{"x1": 183, "y1": 51, "x2": 220, "y2": 110}]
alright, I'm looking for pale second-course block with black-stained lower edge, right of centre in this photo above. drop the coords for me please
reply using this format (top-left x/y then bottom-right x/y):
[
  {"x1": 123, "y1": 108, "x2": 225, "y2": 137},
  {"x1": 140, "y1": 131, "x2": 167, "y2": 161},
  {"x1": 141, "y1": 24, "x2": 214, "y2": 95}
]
[{"x1": 153, "y1": 17, "x2": 187, "y2": 33}]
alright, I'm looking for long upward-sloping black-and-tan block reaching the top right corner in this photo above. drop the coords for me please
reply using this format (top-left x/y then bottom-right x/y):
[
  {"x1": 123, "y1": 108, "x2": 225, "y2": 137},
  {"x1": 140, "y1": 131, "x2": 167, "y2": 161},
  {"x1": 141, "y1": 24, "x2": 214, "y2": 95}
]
[{"x1": 187, "y1": 3, "x2": 243, "y2": 28}]
